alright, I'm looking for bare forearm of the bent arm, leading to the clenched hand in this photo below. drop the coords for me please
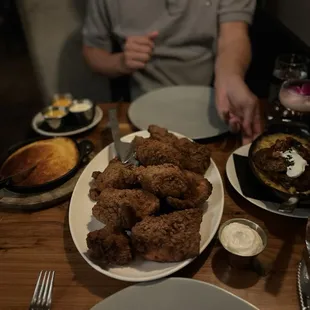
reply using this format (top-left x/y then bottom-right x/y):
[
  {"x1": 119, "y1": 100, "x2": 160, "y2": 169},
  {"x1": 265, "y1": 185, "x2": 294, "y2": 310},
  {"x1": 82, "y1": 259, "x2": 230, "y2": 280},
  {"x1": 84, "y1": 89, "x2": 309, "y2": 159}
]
[{"x1": 83, "y1": 46, "x2": 127, "y2": 78}]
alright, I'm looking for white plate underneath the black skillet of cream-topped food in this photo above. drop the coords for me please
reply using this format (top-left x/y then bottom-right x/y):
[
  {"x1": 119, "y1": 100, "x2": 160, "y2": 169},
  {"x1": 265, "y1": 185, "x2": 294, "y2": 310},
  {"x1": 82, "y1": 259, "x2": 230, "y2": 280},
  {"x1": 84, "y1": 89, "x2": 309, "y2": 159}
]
[{"x1": 226, "y1": 144, "x2": 310, "y2": 218}]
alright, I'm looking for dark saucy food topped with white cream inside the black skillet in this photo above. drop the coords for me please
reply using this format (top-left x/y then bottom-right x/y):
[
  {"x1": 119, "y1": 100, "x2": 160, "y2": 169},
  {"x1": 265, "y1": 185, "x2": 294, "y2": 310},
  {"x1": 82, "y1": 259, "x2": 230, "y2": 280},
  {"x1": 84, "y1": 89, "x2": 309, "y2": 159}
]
[{"x1": 250, "y1": 133, "x2": 310, "y2": 195}]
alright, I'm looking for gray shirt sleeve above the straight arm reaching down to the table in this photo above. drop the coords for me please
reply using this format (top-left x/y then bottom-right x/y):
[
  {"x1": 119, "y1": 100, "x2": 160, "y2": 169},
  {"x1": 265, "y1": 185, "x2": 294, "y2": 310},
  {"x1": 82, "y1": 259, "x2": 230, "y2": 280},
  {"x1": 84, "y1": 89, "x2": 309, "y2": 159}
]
[{"x1": 219, "y1": 0, "x2": 256, "y2": 24}]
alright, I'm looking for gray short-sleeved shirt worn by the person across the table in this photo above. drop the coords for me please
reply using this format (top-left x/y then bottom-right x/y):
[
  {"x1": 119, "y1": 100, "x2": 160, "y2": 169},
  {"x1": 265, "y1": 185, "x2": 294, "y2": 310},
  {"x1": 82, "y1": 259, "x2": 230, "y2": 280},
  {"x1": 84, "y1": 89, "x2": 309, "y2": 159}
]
[{"x1": 83, "y1": 0, "x2": 256, "y2": 97}]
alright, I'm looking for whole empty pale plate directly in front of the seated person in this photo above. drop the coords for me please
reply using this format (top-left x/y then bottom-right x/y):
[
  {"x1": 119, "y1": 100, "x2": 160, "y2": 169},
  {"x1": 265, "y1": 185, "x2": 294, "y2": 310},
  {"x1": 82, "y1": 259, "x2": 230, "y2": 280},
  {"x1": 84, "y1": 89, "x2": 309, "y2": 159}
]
[{"x1": 128, "y1": 86, "x2": 228, "y2": 139}]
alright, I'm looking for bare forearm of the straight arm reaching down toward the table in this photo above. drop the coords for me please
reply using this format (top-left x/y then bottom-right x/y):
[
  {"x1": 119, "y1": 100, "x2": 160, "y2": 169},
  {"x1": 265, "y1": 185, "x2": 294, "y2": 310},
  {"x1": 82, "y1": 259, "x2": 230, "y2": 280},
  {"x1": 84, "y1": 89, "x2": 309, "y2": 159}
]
[{"x1": 215, "y1": 22, "x2": 251, "y2": 82}]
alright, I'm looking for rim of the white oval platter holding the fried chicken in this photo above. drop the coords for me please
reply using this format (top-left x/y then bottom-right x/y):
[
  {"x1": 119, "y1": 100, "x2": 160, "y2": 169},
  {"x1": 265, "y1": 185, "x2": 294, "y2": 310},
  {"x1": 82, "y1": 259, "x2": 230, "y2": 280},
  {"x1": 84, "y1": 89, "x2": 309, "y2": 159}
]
[{"x1": 69, "y1": 130, "x2": 224, "y2": 282}]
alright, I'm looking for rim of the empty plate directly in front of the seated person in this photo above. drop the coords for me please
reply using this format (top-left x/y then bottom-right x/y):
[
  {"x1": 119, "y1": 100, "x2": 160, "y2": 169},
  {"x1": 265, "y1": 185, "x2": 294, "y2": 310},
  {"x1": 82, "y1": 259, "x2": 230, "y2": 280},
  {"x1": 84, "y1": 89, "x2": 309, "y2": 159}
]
[{"x1": 128, "y1": 85, "x2": 229, "y2": 140}]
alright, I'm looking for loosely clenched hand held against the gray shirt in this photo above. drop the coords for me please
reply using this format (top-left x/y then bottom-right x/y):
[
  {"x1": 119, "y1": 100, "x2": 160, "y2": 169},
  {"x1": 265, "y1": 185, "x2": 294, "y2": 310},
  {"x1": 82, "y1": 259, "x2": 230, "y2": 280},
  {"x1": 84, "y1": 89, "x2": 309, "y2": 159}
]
[{"x1": 122, "y1": 31, "x2": 158, "y2": 74}]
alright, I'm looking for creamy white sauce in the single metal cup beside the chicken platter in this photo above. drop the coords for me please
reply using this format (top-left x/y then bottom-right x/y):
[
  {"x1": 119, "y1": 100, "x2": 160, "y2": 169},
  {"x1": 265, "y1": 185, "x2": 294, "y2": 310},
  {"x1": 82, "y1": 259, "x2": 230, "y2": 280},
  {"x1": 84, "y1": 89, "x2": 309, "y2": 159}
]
[{"x1": 220, "y1": 223, "x2": 263, "y2": 256}]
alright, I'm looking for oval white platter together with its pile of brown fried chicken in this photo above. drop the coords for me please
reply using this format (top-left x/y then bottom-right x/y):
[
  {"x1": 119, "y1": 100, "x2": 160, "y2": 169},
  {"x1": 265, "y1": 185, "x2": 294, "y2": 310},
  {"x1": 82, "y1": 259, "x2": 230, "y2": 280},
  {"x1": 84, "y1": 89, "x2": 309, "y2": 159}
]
[{"x1": 69, "y1": 125, "x2": 224, "y2": 282}]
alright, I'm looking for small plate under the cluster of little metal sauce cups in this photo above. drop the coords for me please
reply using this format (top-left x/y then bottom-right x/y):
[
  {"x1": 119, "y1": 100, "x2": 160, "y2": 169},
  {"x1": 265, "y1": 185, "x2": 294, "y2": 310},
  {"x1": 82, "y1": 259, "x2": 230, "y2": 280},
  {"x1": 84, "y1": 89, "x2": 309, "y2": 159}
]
[{"x1": 31, "y1": 106, "x2": 103, "y2": 137}]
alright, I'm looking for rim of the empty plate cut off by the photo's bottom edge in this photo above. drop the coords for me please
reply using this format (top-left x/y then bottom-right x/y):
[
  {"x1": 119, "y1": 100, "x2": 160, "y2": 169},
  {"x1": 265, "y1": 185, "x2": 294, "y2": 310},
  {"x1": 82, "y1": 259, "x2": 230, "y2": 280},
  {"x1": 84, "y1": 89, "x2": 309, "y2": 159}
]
[{"x1": 90, "y1": 277, "x2": 259, "y2": 310}]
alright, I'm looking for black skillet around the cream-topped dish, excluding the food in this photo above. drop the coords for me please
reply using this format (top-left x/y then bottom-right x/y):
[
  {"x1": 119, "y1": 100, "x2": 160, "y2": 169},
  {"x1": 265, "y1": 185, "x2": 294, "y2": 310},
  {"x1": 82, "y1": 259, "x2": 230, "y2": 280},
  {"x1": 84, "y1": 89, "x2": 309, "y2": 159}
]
[{"x1": 249, "y1": 123, "x2": 310, "y2": 208}]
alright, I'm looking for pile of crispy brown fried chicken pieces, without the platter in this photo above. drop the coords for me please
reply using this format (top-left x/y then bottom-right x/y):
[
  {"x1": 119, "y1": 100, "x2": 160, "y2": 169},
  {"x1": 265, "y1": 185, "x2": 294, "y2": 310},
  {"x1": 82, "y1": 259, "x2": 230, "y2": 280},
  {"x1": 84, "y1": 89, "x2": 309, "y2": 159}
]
[{"x1": 87, "y1": 125, "x2": 212, "y2": 265}]
